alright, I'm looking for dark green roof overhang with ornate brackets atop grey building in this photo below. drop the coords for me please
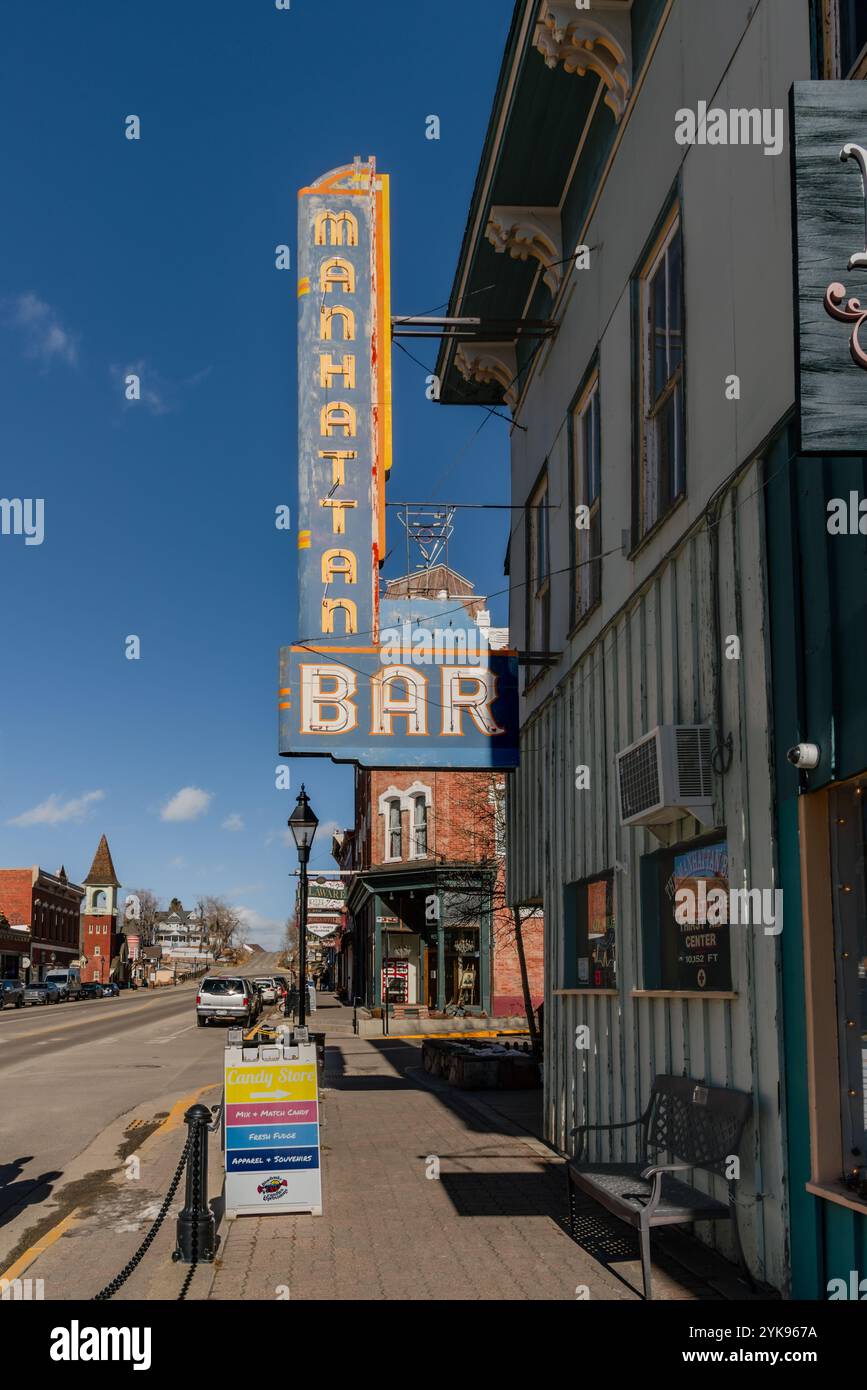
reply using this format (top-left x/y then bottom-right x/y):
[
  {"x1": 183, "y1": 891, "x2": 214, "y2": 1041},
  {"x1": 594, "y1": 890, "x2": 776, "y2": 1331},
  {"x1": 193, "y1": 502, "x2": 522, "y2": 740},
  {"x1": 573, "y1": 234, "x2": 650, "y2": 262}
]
[{"x1": 436, "y1": 0, "x2": 632, "y2": 411}]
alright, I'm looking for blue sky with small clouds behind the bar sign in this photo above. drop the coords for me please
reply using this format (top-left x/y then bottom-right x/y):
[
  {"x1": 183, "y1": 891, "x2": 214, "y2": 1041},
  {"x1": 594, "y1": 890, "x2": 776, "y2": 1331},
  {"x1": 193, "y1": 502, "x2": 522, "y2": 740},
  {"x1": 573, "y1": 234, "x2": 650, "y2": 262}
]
[{"x1": 0, "y1": 0, "x2": 511, "y2": 942}]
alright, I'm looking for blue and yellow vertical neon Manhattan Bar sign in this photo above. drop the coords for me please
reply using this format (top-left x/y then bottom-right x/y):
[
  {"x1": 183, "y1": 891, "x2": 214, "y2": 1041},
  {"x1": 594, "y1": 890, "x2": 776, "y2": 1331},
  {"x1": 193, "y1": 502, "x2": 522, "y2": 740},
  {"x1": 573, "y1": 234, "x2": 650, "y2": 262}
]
[{"x1": 279, "y1": 157, "x2": 517, "y2": 769}]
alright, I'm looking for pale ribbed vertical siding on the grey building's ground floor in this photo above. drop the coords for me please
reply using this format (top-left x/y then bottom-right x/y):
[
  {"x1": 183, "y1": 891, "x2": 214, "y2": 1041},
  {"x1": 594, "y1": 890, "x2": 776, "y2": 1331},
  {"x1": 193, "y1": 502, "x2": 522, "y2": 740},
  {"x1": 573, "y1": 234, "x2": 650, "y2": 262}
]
[{"x1": 509, "y1": 466, "x2": 786, "y2": 1289}]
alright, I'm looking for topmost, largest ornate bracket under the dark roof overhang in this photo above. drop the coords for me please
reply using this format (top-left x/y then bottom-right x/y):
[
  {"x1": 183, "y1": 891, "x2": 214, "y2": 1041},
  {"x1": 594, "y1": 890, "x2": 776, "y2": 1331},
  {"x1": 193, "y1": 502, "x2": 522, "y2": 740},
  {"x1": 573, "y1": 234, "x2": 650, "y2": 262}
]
[{"x1": 534, "y1": 0, "x2": 632, "y2": 121}]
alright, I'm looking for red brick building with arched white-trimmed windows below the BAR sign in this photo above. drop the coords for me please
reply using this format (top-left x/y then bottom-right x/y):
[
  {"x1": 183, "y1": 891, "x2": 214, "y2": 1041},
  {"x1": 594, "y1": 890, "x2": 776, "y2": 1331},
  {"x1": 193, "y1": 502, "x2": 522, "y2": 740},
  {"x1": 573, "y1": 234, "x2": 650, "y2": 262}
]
[{"x1": 332, "y1": 767, "x2": 543, "y2": 1017}]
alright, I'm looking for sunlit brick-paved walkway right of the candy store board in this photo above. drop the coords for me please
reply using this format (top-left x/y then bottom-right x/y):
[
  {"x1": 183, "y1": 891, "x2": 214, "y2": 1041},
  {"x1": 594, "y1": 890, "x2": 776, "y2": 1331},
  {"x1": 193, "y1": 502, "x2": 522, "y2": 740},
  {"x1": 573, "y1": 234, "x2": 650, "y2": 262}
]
[{"x1": 210, "y1": 998, "x2": 644, "y2": 1300}]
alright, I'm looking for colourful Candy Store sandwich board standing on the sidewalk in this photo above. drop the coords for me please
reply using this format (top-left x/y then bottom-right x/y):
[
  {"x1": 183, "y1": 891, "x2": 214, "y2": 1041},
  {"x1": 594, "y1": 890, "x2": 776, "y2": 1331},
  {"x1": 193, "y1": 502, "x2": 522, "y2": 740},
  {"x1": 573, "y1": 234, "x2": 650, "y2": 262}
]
[{"x1": 224, "y1": 1043, "x2": 322, "y2": 1218}]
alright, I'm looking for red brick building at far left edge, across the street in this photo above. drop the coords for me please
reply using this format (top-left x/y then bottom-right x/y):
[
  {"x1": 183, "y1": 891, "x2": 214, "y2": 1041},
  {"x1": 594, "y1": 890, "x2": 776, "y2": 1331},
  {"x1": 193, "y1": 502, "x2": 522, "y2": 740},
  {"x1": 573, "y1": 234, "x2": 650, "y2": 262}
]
[{"x1": 0, "y1": 865, "x2": 85, "y2": 980}]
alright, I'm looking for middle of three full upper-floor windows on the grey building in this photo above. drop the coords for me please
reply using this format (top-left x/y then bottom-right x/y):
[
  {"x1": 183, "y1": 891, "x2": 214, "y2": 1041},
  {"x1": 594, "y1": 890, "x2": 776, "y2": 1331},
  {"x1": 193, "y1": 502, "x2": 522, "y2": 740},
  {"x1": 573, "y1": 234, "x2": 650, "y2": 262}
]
[{"x1": 572, "y1": 373, "x2": 602, "y2": 623}]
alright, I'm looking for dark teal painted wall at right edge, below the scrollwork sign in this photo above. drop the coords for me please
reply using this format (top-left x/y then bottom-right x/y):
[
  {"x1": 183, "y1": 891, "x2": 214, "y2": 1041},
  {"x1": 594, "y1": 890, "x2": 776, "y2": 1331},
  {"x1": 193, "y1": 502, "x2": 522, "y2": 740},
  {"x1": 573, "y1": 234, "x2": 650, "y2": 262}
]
[{"x1": 766, "y1": 428, "x2": 867, "y2": 1298}]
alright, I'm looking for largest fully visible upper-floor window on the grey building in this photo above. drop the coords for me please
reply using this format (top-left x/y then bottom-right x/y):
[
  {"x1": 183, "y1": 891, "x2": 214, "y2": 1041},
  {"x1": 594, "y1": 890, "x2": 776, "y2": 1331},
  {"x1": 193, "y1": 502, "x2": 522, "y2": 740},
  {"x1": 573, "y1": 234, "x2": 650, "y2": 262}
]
[{"x1": 636, "y1": 211, "x2": 686, "y2": 539}]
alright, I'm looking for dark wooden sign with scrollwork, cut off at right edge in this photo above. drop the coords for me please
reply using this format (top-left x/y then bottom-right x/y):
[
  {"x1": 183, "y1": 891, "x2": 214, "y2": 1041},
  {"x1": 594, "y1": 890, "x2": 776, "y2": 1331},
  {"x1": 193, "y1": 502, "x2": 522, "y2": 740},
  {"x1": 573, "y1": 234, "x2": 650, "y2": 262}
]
[{"x1": 791, "y1": 82, "x2": 867, "y2": 455}]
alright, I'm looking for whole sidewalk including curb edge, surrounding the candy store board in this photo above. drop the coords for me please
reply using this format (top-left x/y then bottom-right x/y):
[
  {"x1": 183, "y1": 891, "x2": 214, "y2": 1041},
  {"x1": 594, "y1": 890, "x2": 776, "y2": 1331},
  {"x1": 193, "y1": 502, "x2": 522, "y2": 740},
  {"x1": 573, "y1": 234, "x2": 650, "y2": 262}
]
[{"x1": 10, "y1": 997, "x2": 750, "y2": 1302}]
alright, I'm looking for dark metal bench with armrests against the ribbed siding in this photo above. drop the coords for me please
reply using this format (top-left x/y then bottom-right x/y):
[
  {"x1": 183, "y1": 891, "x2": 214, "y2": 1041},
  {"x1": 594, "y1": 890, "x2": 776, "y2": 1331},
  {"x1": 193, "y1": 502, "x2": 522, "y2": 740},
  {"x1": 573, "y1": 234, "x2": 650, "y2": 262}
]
[{"x1": 565, "y1": 1076, "x2": 753, "y2": 1298}]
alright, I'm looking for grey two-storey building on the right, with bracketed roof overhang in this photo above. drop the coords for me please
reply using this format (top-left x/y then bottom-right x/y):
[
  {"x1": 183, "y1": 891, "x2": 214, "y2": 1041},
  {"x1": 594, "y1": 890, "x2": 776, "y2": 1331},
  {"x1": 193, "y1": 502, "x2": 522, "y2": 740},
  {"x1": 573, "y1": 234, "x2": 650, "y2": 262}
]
[{"x1": 436, "y1": 0, "x2": 867, "y2": 1297}]
